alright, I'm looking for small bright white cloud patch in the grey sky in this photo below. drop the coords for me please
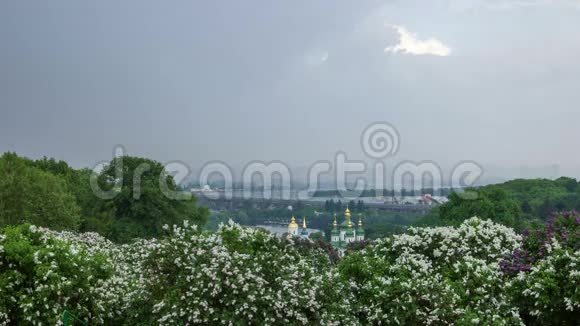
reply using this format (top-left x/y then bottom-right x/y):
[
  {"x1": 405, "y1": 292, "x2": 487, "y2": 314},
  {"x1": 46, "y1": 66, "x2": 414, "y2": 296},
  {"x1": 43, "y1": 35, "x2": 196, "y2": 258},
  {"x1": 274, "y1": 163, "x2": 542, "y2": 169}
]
[{"x1": 385, "y1": 26, "x2": 451, "y2": 57}]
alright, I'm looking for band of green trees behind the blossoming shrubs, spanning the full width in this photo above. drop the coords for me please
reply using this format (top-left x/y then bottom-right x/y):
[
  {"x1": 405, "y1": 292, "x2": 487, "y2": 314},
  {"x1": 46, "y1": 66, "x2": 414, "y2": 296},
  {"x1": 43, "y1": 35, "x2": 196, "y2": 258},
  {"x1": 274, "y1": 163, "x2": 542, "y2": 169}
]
[{"x1": 5, "y1": 153, "x2": 580, "y2": 242}]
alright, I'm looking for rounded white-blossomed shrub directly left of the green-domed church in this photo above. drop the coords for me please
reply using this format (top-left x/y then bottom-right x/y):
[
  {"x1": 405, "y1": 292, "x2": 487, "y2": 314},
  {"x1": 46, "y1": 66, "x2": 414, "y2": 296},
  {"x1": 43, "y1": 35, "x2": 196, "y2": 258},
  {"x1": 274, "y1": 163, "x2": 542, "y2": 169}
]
[{"x1": 139, "y1": 223, "x2": 353, "y2": 325}]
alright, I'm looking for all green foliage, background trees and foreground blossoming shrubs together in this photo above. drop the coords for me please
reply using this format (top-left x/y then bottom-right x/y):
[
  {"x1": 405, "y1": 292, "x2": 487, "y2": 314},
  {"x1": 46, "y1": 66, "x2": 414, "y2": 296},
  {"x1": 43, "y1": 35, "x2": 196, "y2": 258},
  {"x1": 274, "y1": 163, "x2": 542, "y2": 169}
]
[{"x1": 0, "y1": 153, "x2": 580, "y2": 325}]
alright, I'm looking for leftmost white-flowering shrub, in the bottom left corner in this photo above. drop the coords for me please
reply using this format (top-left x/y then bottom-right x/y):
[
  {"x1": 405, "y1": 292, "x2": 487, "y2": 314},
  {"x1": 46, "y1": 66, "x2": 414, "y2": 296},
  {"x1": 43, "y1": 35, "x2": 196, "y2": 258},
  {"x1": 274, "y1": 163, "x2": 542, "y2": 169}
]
[{"x1": 0, "y1": 224, "x2": 114, "y2": 325}]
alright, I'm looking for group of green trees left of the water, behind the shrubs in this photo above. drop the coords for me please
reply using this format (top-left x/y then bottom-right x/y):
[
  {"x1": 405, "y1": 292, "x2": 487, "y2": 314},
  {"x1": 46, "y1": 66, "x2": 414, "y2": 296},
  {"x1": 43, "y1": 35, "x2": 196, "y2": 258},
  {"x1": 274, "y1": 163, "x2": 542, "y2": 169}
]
[{"x1": 0, "y1": 153, "x2": 208, "y2": 242}]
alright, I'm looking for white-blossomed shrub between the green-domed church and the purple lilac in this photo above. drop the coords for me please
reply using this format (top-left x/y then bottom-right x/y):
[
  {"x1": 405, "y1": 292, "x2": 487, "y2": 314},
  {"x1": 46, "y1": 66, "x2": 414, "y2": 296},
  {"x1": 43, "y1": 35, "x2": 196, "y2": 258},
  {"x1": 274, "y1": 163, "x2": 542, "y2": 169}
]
[{"x1": 339, "y1": 218, "x2": 520, "y2": 325}]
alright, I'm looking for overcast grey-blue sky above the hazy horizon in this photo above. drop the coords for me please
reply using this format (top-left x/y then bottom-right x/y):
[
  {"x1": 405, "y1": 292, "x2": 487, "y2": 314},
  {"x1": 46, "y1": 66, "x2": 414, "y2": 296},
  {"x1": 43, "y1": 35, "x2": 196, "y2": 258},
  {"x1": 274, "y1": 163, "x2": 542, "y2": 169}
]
[{"x1": 0, "y1": 0, "x2": 580, "y2": 176}]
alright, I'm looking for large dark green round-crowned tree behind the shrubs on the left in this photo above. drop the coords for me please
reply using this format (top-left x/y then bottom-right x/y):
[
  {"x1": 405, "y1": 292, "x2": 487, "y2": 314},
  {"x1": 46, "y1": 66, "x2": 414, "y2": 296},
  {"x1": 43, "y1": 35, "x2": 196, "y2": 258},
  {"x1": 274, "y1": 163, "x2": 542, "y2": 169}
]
[{"x1": 89, "y1": 156, "x2": 208, "y2": 242}]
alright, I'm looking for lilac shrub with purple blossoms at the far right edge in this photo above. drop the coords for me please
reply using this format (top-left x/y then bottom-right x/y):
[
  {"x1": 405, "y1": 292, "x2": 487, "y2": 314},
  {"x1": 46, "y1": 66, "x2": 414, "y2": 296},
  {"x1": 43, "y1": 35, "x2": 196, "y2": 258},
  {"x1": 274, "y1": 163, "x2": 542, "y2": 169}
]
[{"x1": 500, "y1": 212, "x2": 580, "y2": 325}]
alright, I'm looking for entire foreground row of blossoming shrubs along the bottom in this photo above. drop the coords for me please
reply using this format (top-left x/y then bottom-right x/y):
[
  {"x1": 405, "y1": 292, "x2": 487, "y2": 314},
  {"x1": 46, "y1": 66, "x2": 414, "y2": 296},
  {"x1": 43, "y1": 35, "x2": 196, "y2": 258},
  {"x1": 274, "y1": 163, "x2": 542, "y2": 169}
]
[{"x1": 0, "y1": 215, "x2": 580, "y2": 325}]
